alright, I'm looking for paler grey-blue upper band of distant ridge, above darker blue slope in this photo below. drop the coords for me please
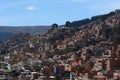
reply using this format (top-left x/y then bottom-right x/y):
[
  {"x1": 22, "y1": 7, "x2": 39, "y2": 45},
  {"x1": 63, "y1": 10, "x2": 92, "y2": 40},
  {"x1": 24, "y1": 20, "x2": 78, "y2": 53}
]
[{"x1": 0, "y1": 26, "x2": 50, "y2": 34}]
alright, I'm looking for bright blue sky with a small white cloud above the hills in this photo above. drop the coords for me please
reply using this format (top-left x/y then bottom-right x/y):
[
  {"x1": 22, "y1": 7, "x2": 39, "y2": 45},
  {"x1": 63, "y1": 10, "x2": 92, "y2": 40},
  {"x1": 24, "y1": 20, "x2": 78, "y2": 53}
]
[{"x1": 0, "y1": 0, "x2": 120, "y2": 26}]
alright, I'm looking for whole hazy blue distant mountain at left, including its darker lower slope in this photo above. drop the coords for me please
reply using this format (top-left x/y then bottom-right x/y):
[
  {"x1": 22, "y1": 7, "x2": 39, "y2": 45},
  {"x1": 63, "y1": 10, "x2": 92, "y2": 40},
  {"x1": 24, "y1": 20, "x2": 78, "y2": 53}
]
[{"x1": 0, "y1": 26, "x2": 50, "y2": 42}]
